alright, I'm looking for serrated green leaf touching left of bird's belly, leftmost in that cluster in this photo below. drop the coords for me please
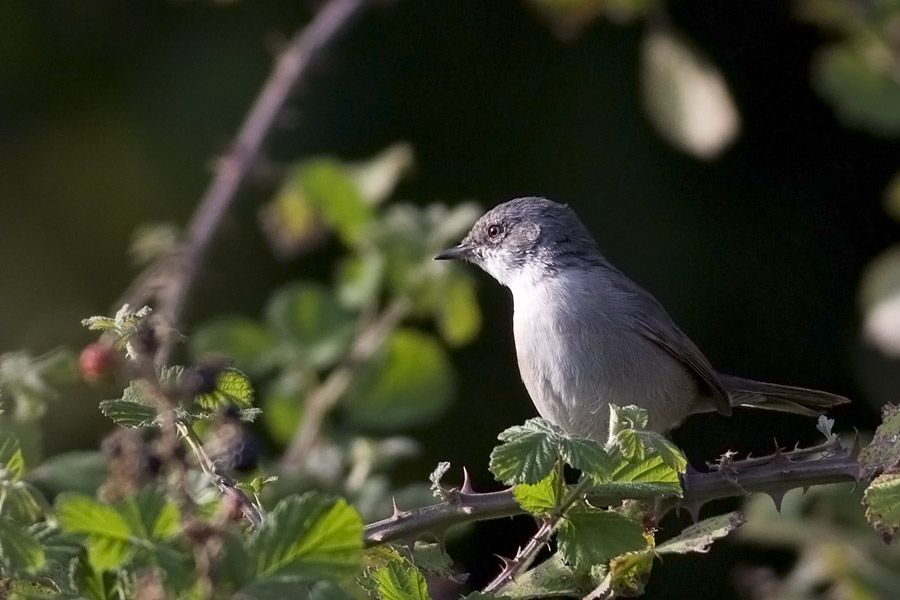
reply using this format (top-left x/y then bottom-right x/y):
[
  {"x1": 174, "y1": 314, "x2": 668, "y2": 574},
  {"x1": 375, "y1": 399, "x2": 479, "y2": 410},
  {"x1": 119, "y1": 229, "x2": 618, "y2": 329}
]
[{"x1": 490, "y1": 418, "x2": 563, "y2": 485}]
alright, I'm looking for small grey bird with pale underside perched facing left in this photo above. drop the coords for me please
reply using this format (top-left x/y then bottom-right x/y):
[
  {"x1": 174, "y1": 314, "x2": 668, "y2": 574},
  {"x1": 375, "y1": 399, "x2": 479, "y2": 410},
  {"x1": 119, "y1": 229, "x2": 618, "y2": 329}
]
[{"x1": 435, "y1": 198, "x2": 849, "y2": 442}]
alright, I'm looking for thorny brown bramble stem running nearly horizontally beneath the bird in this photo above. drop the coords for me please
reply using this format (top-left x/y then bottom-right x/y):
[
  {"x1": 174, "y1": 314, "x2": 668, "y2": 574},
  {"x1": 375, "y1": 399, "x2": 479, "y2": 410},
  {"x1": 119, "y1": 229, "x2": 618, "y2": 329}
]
[{"x1": 364, "y1": 450, "x2": 860, "y2": 546}]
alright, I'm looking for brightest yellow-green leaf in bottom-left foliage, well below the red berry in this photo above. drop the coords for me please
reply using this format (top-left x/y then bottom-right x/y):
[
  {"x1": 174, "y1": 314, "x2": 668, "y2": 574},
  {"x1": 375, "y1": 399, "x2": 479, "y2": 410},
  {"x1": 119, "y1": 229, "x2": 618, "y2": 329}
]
[{"x1": 56, "y1": 494, "x2": 131, "y2": 571}]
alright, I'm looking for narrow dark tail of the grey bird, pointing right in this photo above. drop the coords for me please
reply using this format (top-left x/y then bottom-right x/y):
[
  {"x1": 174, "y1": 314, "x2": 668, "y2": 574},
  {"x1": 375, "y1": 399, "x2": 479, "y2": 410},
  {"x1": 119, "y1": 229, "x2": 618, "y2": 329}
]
[{"x1": 719, "y1": 375, "x2": 850, "y2": 417}]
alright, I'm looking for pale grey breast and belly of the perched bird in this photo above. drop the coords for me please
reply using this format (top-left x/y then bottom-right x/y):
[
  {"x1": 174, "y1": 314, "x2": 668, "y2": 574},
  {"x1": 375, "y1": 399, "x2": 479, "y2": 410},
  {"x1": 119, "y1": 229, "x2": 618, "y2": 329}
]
[{"x1": 510, "y1": 267, "x2": 696, "y2": 441}]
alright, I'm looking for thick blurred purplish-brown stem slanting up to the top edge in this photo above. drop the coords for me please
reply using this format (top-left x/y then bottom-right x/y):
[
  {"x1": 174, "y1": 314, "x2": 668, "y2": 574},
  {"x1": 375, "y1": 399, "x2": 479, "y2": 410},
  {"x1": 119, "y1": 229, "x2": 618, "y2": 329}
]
[{"x1": 119, "y1": 0, "x2": 372, "y2": 363}]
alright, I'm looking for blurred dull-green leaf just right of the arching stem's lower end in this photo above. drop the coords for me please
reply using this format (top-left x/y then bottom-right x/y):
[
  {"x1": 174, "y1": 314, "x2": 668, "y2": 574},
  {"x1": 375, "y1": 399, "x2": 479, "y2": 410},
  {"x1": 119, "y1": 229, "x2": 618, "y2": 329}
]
[{"x1": 190, "y1": 317, "x2": 276, "y2": 375}]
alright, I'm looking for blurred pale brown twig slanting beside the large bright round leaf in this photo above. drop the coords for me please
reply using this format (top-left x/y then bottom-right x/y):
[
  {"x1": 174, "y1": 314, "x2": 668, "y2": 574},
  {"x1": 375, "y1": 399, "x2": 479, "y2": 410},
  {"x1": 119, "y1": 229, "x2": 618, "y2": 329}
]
[{"x1": 281, "y1": 298, "x2": 412, "y2": 471}]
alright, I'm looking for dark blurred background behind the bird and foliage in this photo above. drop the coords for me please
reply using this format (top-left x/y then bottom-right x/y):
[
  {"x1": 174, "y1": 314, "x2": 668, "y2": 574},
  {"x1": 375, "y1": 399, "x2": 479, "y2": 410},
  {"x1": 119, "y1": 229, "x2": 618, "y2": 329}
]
[{"x1": 0, "y1": 0, "x2": 900, "y2": 598}]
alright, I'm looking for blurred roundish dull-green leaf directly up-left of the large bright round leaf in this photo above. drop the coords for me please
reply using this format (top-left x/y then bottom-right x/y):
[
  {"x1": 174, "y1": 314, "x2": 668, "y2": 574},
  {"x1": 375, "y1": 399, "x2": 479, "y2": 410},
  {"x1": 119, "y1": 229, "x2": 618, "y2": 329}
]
[{"x1": 266, "y1": 283, "x2": 355, "y2": 368}]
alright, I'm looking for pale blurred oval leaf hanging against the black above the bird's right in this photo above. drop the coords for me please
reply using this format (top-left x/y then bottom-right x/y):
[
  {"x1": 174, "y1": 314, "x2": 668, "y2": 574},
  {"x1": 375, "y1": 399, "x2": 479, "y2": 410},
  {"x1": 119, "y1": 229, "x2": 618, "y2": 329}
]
[{"x1": 641, "y1": 29, "x2": 740, "y2": 159}]
